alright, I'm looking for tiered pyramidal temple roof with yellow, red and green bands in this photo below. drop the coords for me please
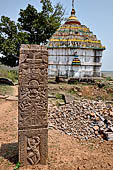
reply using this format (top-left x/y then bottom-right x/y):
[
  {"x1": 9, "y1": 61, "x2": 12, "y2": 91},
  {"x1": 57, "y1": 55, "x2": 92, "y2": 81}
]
[{"x1": 48, "y1": 8, "x2": 105, "y2": 50}]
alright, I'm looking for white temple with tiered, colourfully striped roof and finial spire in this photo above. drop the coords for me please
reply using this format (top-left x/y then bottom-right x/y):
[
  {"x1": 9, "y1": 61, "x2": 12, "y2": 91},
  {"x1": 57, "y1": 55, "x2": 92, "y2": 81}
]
[{"x1": 48, "y1": 0, "x2": 105, "y2": 79}]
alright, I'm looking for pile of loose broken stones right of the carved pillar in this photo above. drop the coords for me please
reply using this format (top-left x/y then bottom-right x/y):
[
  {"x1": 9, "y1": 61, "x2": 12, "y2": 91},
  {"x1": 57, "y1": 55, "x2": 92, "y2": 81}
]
[{"x1": 48, "y1": 99, "x2": 113, "y2": 140}]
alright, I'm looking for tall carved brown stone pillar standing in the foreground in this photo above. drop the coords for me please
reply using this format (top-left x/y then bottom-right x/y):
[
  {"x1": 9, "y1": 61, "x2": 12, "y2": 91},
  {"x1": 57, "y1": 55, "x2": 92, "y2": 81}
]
[{"x1": 18, "y1": 45, "x2": 48, "y2": 165}]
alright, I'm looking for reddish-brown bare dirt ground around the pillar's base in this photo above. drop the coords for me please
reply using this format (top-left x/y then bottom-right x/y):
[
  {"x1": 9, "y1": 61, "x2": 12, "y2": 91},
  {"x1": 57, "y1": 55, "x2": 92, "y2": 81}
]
[{"x1": 0, "y1": 87, "x2": 113, "y2": 170}]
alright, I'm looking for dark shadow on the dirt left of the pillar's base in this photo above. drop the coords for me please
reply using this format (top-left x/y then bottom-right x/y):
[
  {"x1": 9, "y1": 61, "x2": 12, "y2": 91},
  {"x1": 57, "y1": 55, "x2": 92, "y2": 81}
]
[{"x1": 0, "y1": 143, "x2": 18, "y2": 164}]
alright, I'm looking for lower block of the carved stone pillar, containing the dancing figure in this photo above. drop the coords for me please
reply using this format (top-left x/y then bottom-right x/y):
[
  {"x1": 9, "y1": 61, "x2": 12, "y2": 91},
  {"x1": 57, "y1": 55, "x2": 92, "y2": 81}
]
[{"x1": 19, "y1": 128, "x2": 48, "y2": 165}]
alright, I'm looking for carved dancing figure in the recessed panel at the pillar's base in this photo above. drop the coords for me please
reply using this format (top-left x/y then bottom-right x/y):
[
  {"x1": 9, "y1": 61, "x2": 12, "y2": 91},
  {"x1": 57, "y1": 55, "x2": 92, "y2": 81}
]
[{"x1": 27, "y1": 137, "x2": 40, "y2": 165}]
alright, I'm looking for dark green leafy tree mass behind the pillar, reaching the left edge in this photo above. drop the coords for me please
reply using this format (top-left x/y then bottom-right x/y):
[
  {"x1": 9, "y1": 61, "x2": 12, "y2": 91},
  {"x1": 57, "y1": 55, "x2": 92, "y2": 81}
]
[{"x1": 0, "y1": 0, "x2": 64, "y2": 67}]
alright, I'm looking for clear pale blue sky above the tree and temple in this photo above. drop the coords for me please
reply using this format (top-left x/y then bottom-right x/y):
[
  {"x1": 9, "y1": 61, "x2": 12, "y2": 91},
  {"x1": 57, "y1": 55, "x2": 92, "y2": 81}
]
[{"x1": 0, "y1": 0, "x2": 113, "y2": 71}]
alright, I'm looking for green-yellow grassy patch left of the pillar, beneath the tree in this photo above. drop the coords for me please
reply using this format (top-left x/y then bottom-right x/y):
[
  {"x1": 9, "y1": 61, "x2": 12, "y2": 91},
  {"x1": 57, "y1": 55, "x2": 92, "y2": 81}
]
[{"x1": 0, "y1": 69, "x2": 18, "y2": 82}]
